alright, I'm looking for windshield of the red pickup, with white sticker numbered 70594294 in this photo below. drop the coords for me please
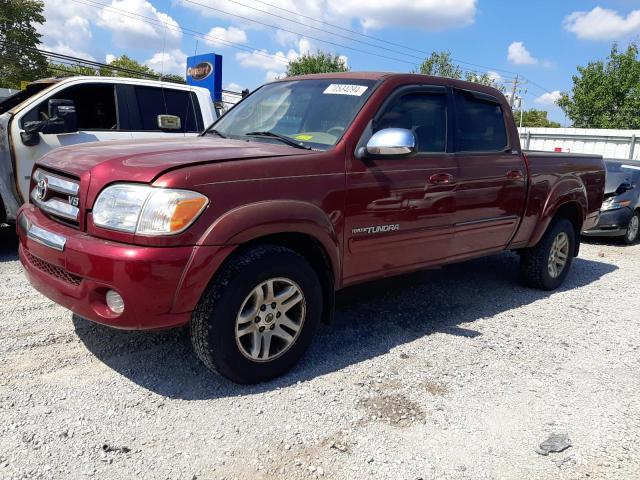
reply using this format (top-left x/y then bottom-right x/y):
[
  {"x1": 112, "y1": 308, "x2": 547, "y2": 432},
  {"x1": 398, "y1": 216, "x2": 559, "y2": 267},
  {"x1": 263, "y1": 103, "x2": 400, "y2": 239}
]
[{"x1": 210, "y1": 79, "x2": 375, "y2": 150}]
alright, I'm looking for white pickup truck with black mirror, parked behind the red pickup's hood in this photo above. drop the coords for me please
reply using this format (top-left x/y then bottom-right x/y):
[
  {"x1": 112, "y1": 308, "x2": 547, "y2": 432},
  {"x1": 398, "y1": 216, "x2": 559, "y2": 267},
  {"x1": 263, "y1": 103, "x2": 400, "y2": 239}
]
[{"x1": 0, "y1": 77, "x2": 218, "y2": 224}]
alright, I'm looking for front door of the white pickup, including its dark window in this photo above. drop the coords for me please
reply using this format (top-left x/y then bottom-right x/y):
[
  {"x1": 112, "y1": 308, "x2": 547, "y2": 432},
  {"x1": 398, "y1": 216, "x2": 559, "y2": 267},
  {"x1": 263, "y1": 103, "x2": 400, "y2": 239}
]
[{"x1": 11, "y1": 83, "x2": 131, "y2": 202}]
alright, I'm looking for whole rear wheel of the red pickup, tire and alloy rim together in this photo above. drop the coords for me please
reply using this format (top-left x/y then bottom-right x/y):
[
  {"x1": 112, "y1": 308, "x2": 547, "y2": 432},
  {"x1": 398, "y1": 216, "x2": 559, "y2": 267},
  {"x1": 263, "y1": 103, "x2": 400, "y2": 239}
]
[{"x1": 520, "y1": 218, "x2": 576, "y2": 290}]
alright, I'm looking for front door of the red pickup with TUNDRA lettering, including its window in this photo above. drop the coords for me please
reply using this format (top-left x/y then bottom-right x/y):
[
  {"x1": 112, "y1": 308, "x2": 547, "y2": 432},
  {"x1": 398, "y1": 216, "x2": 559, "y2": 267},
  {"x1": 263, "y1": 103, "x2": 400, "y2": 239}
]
[{"x1": 344, "y1": 86, "x2": 458, "y2": 284}]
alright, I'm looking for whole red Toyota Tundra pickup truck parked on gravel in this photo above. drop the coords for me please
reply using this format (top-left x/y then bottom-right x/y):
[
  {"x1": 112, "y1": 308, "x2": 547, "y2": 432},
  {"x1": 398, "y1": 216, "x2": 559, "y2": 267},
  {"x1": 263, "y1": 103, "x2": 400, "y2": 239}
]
[{"x1": 17, "y1": 73, "x2": 605, "y2": 383}]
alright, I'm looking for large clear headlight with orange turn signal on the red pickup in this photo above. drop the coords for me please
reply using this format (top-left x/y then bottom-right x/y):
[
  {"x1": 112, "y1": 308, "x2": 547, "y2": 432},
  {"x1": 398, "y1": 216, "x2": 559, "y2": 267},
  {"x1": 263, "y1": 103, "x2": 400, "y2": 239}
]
[{"x1": 93, "y1": 184, "x2": 209, "y2": 235}]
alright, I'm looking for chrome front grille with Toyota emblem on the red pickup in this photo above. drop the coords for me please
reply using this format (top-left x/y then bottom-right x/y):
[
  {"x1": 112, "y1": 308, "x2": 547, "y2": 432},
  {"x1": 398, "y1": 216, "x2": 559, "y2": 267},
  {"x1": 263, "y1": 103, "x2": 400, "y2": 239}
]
[{"x1": 31, "y1": 168, "x2": 80, "y2": 228}]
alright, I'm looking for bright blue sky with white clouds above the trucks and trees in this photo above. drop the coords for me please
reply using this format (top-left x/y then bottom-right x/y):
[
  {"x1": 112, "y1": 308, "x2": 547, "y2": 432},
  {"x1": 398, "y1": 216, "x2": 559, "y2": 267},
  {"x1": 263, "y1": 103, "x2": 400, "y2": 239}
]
[{"x1": 39, "y1": 0, "x2": 640, "y2": 125}]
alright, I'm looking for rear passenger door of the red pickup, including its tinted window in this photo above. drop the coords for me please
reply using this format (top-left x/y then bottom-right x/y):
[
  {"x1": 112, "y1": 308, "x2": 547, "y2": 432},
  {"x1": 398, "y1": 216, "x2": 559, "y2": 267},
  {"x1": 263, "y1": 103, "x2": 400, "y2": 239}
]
[{"x1": 451, "y1": 89, "x2": 527, "y2": 256}]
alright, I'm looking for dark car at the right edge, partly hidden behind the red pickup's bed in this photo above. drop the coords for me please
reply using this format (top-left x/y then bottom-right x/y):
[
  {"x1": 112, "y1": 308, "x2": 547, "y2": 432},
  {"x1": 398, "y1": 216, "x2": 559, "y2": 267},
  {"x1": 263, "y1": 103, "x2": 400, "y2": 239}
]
[{"x1": 582, "y1": 160, "x2": 640, "y2": 245}]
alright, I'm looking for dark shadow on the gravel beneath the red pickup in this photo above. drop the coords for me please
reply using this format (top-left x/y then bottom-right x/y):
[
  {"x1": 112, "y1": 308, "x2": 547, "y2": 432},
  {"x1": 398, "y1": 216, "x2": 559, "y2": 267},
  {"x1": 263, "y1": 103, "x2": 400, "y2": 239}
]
[{"x1": 73, "y1": 253, "x2": 617, "y2": 400}]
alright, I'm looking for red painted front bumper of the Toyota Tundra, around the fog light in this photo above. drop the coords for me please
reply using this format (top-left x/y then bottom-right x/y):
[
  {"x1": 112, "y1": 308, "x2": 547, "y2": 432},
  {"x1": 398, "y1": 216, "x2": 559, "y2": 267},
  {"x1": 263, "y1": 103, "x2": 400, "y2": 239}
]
[{"x1": 18, "y1": 205, "x2": 228, "y2": 329}]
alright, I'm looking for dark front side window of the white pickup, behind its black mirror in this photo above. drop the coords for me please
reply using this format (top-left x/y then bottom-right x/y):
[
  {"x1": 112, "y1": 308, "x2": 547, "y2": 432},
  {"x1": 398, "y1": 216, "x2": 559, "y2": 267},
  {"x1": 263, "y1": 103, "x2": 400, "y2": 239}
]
[{"x1": 21, "y1": 84, "x2": 118, "y2": 130}]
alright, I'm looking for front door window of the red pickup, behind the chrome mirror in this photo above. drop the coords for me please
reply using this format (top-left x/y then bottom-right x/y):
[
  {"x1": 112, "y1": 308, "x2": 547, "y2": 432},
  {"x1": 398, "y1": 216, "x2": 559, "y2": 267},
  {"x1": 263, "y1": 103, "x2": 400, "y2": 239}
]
[{"x1": 373, "y1": 93, "x2": 447, "y2": 153}]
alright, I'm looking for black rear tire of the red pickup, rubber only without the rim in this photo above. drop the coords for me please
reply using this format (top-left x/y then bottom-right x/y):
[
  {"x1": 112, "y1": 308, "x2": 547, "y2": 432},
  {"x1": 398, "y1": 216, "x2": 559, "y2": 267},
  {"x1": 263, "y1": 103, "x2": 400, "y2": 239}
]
[{"x1": 520, "y1": 218, "x2": 576, "y2": 290}]
